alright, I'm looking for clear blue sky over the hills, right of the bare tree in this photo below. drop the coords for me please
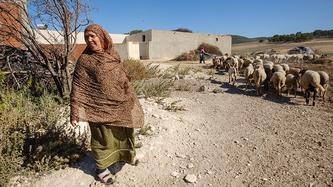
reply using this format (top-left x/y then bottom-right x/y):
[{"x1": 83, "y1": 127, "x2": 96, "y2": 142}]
[{"x1": 89, "y1": 0, "x2": 333, "y2": 37}]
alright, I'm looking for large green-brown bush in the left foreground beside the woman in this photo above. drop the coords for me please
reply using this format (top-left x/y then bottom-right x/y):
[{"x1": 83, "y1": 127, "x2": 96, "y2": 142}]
[{"x1": 0, "y1": 88, "x2": 85, "y2": 186}]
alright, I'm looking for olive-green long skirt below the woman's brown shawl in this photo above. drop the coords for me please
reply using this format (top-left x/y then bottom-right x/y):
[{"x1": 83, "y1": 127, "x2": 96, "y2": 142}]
[{"x1": 89, "y1": 123, "x2": 135, "y2": 169}]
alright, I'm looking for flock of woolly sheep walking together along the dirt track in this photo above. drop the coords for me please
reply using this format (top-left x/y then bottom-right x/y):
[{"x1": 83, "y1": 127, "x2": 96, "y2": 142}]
[{"x1": 213, "y1": 54, "x2": 329, "y2": 106}]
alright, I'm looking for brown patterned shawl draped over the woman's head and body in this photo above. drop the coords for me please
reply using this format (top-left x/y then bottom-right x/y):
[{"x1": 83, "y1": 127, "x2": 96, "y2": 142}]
[{"x1": 71, "y1": 24, "x2": 144, "y2": 128}]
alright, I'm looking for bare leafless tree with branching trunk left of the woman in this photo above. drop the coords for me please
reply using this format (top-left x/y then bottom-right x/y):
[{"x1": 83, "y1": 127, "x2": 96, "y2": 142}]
[{"x1": 0, "y1": 0, "x2": 89, "y2": 97}]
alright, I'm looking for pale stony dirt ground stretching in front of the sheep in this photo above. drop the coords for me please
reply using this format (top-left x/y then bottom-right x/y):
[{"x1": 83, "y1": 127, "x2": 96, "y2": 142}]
[{"x1": 9, "y1": 63, "x2": 333, "y2": 187}]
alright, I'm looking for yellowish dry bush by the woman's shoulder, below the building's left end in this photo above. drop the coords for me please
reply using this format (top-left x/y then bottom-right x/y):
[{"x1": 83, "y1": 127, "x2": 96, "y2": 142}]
[{"x1": 124, "y1": 59, "x2": 161, "y2": 81}]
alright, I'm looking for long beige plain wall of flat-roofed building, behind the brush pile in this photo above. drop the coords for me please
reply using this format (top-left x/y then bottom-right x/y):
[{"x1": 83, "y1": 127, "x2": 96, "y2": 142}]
[{"x1": 149, "y1": 30, "x2": 231, "y2": 60}]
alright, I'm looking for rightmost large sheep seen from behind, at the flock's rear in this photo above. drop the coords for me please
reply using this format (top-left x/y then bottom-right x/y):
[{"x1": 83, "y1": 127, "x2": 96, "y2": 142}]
[{"x1": 300, "y1": 70, "x2": 325, "y2": 106}]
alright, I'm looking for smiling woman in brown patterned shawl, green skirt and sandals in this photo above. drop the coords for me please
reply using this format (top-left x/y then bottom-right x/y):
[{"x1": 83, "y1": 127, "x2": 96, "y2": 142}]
[{"x1": 71, "y1": 24, "x2": 143, "y2": 184}]
